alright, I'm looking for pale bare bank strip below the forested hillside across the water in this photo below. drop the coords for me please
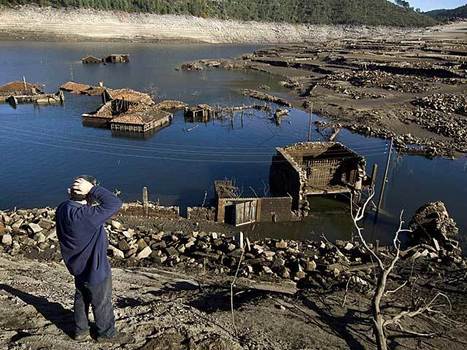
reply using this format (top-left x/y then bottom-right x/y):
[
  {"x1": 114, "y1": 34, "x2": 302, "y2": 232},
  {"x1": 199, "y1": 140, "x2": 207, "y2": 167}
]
[{"x1": 0, "y1": 6, "x2": 419, "y2": 44}]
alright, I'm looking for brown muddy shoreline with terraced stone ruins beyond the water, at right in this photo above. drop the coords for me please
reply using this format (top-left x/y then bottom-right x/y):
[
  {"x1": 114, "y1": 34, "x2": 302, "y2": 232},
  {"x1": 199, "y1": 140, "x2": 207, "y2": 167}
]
[{"x1": 181, "y1": 22, "x2": 467, "y2": 157}]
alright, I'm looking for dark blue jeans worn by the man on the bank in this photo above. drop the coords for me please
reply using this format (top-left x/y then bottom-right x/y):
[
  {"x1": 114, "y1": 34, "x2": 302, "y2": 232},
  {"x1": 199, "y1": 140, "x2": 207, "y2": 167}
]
[{"x1": 74, "y1": 276, "x2": 115, "y2": 337}]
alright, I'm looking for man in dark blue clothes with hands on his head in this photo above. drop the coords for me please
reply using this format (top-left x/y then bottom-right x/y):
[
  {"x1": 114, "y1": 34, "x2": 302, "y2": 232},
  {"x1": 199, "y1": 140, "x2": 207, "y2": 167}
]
[{"x1": 55, "y1": 175, "x2": 122, "y2": 342}]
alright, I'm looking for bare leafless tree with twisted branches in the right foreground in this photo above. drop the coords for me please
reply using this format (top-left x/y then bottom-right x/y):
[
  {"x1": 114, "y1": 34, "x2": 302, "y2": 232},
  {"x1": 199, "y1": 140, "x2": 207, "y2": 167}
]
[{"x1": 350, "y1": 190, "x2": 451, "y2": 350}]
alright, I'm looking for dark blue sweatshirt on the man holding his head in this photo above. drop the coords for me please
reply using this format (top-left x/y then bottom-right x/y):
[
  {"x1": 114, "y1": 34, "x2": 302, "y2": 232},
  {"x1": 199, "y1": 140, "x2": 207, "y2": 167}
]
[{"x1": 55, "y1": 186, "x2": 122, "y2": 284}]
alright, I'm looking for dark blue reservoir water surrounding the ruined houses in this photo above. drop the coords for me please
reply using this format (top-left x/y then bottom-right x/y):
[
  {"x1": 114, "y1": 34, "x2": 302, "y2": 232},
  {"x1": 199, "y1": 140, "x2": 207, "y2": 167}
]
[{"x1": 0, "y1": 42, "x2": 467, "y2": 246}]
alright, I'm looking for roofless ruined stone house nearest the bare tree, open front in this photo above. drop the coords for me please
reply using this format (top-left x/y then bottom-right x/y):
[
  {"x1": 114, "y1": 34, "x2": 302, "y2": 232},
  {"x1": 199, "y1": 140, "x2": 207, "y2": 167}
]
[{"x1": 270, "y1": 142, "x2": 367, "y2": 210}]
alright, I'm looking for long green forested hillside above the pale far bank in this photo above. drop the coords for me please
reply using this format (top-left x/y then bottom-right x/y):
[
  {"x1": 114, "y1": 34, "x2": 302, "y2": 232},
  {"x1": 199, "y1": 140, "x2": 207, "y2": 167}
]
[{"x1": 0, "y1": 0, "x2": 435, "y2": 26}]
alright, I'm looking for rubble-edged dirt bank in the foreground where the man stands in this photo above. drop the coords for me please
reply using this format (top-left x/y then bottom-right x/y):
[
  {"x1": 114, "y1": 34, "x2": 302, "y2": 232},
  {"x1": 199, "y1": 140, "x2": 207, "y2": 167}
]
[{"x1": 0, "y1": 203, "x2": 467, "y2": 350}]
